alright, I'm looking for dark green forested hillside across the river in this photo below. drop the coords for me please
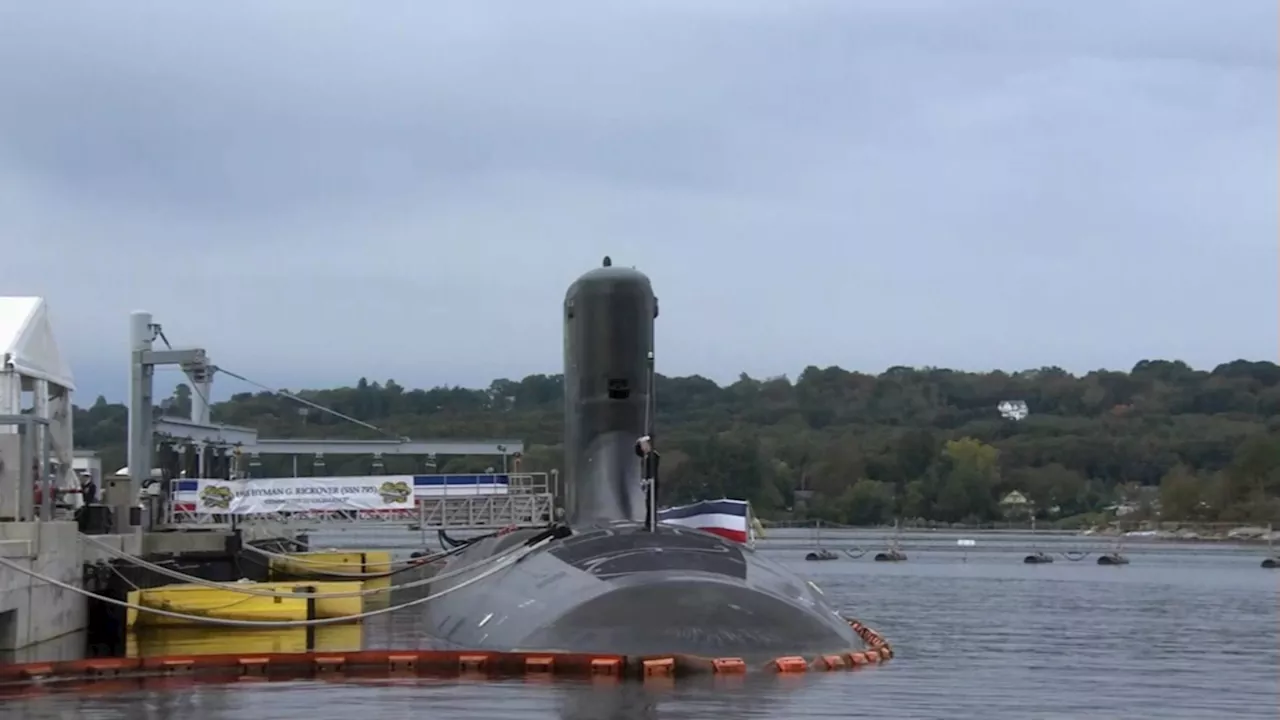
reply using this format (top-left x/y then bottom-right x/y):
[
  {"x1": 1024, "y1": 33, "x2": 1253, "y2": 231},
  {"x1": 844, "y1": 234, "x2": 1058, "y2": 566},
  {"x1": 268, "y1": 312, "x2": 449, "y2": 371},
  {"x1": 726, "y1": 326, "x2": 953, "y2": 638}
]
[{"x1": 76, "y1": 360, "x2": 1280, "y2": 523}]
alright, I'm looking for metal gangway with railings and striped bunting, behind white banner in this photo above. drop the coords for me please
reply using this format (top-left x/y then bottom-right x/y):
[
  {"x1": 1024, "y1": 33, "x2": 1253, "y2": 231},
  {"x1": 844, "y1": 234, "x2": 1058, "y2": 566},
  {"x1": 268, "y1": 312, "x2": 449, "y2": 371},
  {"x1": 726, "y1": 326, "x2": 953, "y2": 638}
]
[{"x1": 155, "y1": 471, "x2": 559, "y2": 530}]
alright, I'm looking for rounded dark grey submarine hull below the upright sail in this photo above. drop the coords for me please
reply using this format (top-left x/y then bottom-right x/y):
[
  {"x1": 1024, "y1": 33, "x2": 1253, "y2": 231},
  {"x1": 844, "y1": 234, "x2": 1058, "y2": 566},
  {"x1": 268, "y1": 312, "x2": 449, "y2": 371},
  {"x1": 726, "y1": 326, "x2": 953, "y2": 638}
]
[{"x1": 426, "y1": 523, "x2": 861, "y2": 662}]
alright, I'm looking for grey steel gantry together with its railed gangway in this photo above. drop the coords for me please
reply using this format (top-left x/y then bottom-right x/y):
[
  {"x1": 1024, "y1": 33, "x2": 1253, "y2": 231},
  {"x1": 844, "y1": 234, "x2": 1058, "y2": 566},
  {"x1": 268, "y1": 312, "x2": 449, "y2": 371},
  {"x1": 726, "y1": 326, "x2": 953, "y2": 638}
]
[{"x1": 122, "y1": 311, "x2": 556, "y2": 530}]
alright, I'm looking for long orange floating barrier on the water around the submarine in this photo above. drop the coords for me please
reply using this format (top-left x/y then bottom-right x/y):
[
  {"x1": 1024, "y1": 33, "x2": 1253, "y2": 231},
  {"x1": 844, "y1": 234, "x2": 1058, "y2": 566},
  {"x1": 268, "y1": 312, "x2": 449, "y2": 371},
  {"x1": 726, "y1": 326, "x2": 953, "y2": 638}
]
[{"x1": 0, "y1": 620, "x2": 893, "y2": 697}]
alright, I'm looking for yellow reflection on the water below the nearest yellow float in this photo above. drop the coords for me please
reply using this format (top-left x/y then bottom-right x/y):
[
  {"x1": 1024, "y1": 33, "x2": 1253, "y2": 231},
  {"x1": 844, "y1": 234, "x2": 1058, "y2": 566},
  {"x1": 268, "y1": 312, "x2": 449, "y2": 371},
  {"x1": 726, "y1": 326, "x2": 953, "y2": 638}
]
[{"x1": 125, "y1": 624, "x2": 364, "y2": 657}]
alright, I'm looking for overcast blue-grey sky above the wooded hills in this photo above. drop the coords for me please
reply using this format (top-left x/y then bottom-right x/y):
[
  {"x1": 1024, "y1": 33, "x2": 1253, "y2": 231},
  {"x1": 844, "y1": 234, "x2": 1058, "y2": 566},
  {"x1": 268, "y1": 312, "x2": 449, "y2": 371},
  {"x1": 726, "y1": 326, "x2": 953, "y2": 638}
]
[{"x1": 0, "y1": 0, "x2": 1280, "y2": 402}]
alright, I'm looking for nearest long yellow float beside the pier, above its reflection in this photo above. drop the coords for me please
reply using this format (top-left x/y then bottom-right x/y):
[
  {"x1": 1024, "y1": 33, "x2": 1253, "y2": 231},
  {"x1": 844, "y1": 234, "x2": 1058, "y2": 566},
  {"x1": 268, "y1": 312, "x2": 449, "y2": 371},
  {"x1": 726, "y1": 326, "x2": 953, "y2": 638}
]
[{"x1": 125, "y1": 580, "x2": 364, "y2": 628}]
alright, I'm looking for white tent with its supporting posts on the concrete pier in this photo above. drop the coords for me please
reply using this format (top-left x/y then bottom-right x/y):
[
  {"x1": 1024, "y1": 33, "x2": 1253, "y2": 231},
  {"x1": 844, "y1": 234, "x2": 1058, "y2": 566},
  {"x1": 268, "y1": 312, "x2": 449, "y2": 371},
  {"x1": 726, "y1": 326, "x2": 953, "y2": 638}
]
[{"x1": 0, "y1": 297, "x2": 81, "y2": 518}]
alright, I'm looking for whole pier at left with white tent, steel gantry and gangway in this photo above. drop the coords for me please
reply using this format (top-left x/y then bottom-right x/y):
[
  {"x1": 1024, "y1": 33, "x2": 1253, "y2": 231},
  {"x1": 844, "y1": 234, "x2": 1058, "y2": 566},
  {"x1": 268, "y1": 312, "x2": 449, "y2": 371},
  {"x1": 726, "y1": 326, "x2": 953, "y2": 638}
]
[{"x1": 0, "y1": 297, "x2": 547, "y2": 652}]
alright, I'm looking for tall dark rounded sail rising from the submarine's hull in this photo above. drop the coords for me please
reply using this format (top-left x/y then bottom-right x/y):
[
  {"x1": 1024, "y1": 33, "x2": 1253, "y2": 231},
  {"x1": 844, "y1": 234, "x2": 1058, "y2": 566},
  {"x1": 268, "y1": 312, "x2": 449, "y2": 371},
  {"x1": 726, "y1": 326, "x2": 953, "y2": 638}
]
[{"x1": 563, "y1": 258, "x2": 658, "y2": 527}]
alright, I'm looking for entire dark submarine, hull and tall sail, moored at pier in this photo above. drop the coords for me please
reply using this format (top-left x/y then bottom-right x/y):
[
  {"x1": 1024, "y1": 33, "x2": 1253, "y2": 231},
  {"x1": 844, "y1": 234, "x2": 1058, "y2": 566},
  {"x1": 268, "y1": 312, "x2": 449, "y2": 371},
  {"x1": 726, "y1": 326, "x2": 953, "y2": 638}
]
[{"x1": 420, "y1": 258, "x2": 861, "y2": 664}]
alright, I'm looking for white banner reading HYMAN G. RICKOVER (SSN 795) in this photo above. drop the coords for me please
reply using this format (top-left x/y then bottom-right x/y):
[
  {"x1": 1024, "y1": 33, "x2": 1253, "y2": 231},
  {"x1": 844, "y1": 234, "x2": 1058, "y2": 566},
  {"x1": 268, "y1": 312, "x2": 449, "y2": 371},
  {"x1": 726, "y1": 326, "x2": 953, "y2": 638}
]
[{"x1": 196, "y1": 475, "x2": 413, "y2": 515}]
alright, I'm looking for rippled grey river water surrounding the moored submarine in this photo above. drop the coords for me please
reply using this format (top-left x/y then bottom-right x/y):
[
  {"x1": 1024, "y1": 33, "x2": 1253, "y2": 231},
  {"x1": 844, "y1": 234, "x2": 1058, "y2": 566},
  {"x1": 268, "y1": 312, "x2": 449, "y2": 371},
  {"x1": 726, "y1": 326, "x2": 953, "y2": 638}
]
[{"x1": 0, "y1": 530, "x2": 1280, "y2": 720}]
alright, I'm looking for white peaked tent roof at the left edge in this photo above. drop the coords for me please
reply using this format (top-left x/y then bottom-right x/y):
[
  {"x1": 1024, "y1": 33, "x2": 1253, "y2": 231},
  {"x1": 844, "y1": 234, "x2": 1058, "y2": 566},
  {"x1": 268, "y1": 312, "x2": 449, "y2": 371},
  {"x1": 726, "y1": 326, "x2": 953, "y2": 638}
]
[{"x1": 0, "y1": 297, "x2": 76, "y2": 391}]
